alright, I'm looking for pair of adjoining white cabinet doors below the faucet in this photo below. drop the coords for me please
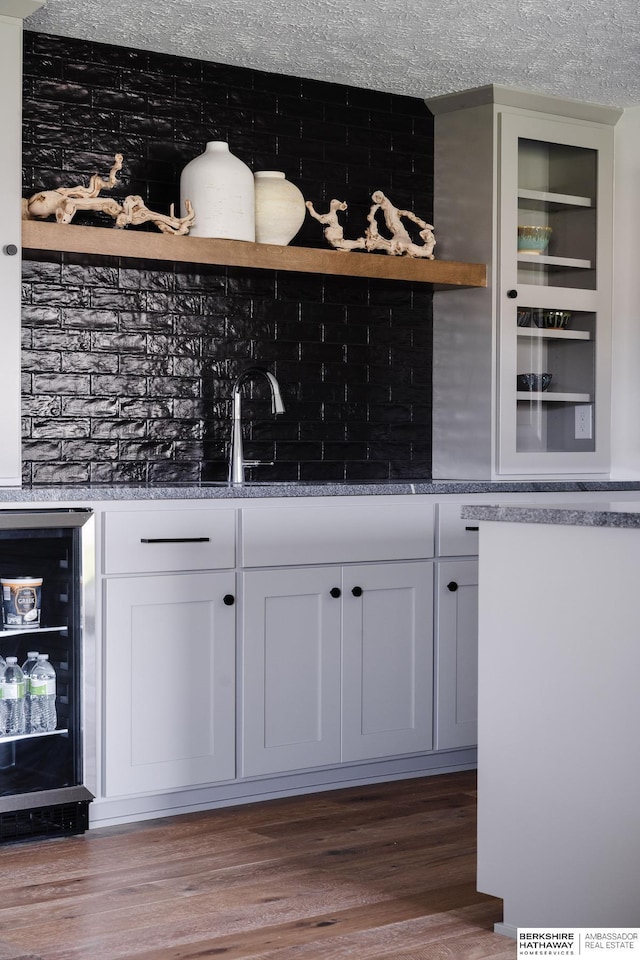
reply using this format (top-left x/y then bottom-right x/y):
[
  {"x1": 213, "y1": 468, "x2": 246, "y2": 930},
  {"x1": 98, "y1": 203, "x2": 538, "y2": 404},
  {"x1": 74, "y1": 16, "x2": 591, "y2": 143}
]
[{"x1": 242, "y1": 561, "x2": 433, "y2": 777}]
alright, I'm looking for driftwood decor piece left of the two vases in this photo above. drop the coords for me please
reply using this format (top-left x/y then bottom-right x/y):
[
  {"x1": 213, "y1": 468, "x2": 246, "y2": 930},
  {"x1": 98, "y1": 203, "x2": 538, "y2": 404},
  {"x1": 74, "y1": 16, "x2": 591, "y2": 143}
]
[{"x1": 22, "y1": 153, "x2": 195, "y2": 235}]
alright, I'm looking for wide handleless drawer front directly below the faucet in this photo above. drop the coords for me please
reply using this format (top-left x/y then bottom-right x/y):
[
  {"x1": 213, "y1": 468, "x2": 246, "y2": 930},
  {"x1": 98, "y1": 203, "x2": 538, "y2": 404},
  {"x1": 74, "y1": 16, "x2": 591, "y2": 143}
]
[{"x1": 242, "y1": 503, "x2": 433, "y2": 567}]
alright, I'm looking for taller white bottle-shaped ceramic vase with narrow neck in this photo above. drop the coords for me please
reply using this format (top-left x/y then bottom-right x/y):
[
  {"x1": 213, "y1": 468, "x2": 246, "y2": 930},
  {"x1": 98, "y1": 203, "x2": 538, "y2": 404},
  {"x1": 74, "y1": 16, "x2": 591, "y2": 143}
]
[{"x1": 180, "y1": 140, "x2": 256, "y2": 243}]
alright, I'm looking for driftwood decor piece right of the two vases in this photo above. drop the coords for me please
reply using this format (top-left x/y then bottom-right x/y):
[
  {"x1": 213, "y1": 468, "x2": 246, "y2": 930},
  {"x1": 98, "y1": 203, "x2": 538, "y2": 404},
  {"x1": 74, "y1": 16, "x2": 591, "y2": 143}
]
[{"x1": 306, "y1": 190, "x2": 436, "y2": 260}]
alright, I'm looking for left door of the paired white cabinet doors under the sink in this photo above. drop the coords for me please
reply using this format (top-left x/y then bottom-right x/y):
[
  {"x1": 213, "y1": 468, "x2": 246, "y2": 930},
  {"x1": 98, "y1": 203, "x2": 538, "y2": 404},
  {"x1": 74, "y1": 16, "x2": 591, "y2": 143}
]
[{"x1": 242, "y1": 567, "x2": 341, "y2": 777}]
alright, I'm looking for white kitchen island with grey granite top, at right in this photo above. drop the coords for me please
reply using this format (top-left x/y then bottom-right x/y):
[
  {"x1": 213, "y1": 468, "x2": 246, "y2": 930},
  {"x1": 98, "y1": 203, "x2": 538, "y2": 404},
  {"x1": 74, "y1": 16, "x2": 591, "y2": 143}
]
[{"x1": 462, "y1": 500, "x2": 640, "y2": 936}]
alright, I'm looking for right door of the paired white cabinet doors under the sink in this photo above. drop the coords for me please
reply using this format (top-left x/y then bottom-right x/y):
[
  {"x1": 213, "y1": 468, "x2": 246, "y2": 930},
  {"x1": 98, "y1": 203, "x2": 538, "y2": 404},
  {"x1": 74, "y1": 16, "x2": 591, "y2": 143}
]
[{"x1": 342, "y1": 561, "x2": 433, "y2": 761}]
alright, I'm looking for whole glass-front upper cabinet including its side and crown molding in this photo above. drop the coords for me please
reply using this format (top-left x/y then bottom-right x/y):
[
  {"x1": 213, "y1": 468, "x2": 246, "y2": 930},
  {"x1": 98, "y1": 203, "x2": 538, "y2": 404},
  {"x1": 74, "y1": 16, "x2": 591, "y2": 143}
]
[{"x1": 427, "y1": 84, "x2": 622, "y2": 481}]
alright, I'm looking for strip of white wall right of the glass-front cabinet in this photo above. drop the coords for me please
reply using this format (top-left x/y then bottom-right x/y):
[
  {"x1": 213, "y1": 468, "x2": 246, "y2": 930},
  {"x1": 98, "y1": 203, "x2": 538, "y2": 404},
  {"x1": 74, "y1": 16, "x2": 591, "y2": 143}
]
[{"x1": 611, "y1": 106, "x2": 640, "y2": 479}]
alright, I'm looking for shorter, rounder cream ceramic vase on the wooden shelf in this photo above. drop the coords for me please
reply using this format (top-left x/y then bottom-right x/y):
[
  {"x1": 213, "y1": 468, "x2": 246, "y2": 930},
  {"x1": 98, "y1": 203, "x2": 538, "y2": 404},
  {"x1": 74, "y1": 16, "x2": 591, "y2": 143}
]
[{"x1": 254, "y1": 170, "x2": 307, "y2": 246}]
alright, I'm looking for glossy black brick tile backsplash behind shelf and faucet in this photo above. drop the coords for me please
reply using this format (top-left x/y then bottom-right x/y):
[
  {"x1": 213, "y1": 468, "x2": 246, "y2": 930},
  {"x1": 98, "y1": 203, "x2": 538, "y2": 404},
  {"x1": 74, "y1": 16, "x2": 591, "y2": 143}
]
[{"x1": 22, "y1": 31, "x2": 433, "y2": 483}]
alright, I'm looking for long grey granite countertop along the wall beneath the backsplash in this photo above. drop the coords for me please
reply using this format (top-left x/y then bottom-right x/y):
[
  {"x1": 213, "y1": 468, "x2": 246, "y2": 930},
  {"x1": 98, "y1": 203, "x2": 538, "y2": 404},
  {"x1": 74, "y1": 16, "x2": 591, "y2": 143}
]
[{"x1": 0, "y1": 480, "x2": 640, "y2": 502}]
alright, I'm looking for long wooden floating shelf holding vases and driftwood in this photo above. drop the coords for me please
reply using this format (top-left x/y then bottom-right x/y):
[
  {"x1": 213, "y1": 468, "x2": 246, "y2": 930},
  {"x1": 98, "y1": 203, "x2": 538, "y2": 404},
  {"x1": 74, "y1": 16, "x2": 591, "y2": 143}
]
[{"x1": 22, "y1": 220, "x2": 487, "y2": 287}]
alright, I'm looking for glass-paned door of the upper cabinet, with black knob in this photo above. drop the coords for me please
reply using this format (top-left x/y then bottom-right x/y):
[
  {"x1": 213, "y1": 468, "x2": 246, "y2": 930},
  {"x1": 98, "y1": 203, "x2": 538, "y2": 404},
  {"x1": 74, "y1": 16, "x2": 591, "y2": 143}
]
[{"x1": 497, "y1": 112, "x2": 612, "y2": 476}]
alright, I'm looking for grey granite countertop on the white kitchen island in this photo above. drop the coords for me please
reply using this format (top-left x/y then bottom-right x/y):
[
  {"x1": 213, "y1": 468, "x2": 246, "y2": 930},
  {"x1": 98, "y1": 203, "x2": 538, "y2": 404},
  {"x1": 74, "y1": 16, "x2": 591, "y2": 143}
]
[{"x1": 460, "y1": 498, "x2": 640, "y2": 527}]
